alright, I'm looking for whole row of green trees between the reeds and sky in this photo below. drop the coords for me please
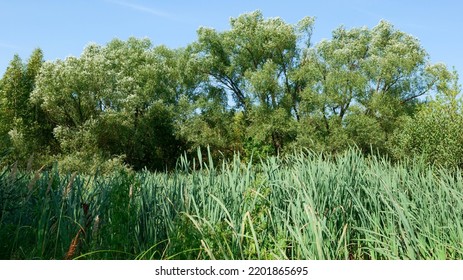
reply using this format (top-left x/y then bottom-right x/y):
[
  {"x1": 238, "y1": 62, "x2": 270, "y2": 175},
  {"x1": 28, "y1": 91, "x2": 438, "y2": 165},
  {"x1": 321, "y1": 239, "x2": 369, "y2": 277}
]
[{"x1": 0, "y1": 12, "x2": 463, "y2": 171}]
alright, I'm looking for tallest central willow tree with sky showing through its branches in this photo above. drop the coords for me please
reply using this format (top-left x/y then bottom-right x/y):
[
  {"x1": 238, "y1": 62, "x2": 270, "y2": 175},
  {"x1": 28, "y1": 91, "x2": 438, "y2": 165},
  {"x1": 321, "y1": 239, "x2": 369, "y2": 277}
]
[{"x1": 194, "y1": 11, "x2": 313, "y2": 153}]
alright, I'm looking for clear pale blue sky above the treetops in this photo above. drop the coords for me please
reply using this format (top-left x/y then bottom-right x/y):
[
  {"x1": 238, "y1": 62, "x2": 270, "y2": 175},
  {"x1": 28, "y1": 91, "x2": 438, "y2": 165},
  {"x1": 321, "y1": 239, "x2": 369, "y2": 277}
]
[{"x1": 0, "y1": 0, "x2": 463, "y2": 79}]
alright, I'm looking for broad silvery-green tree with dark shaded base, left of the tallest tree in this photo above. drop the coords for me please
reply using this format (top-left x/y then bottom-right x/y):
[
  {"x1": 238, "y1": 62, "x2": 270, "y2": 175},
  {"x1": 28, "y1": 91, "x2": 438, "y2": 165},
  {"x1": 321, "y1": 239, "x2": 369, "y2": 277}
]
[{"x1": 32, "y1": 38, "x2": 188, "y2": 172}]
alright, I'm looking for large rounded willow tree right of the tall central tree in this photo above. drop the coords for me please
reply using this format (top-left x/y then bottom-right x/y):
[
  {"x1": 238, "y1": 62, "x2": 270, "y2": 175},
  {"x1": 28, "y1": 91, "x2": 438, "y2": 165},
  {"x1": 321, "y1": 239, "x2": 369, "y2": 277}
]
[{"x1": 295, "y1": 21, "x2": 448, "y2": 152}]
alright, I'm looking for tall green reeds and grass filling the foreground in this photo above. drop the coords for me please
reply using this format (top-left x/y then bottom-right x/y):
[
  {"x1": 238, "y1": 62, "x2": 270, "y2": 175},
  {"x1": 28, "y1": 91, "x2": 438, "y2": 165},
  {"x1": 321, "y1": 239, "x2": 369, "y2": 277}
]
[{"x1": 0, "y1": 150, "x2": 463, "y2": 259}]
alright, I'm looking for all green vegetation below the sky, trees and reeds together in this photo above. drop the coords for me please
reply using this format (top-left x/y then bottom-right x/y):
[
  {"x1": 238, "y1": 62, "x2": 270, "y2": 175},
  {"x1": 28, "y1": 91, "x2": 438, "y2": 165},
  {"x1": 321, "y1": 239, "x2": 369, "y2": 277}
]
[{"x1": 0, "y1": 11, "x2": 463, "y2": 259}]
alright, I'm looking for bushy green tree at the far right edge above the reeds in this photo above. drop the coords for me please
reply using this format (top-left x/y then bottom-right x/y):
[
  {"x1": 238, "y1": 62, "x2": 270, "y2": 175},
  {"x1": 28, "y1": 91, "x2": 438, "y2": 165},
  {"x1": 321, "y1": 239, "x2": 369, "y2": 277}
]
[{"x1": 389, "y1": 68, "x2": 463, "y2": 168}]
